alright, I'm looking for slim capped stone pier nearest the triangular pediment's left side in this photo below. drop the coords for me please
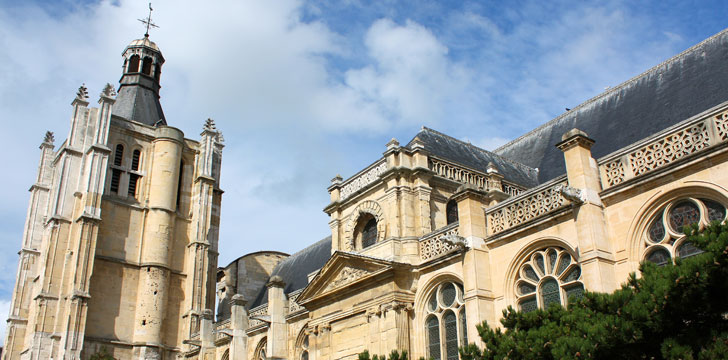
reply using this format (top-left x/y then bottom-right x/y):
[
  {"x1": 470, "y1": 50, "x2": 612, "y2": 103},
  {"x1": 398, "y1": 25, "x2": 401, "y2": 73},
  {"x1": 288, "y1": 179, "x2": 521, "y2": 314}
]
[{"x1": 265, "y1": 275, "x2": 288, "y2": 359}]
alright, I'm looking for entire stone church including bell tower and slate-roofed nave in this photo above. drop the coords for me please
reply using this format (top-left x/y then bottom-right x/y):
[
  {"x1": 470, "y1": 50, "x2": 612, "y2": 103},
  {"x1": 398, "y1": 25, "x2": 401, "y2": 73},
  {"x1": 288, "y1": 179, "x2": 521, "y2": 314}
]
[{"x1": 3, "y1": 23, "x2": 728, "y2": 360}]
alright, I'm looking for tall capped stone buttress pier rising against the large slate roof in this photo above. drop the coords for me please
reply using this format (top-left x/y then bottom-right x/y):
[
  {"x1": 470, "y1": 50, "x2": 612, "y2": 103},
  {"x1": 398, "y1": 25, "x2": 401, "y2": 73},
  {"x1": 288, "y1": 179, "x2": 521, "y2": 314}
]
[{"x1": 556, "y1": 129, "x2": 617, "y2": 292}]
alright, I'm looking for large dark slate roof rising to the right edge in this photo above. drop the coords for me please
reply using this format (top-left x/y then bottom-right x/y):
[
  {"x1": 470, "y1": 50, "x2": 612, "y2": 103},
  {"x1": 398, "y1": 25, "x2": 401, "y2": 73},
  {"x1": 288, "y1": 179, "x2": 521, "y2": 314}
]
[{"x1": 494, "y1": 29, "x2": 728, "y2": 183}]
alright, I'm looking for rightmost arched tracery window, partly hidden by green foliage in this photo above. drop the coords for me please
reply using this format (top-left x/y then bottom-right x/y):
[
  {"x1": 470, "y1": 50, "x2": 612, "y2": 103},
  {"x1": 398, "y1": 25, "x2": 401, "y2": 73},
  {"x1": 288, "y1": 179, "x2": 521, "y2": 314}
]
[{"x1": 643, "y1": 198, "x2": 726, "y2": 266}]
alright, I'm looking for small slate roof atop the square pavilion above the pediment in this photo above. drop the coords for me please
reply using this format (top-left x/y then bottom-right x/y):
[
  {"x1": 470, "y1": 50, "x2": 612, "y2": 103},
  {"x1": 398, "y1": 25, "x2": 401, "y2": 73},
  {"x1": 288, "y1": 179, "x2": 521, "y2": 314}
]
[{"x1": 407, "y1": 127, "x2": 538, "y2": 187}]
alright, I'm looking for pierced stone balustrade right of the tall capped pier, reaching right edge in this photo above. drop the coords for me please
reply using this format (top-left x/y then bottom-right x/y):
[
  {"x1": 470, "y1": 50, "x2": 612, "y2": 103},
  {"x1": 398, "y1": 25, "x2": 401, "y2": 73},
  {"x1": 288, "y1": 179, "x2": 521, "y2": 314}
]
[{"x1": 600, "y1": 110, "x2": 728, "y2": 189}]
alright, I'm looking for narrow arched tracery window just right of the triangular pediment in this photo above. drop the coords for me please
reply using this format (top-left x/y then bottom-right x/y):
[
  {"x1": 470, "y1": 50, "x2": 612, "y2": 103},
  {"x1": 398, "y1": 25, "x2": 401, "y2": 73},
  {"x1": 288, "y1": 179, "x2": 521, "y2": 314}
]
[{"x1": 425, "y1": 281, "x2": 468, "y2": 360}]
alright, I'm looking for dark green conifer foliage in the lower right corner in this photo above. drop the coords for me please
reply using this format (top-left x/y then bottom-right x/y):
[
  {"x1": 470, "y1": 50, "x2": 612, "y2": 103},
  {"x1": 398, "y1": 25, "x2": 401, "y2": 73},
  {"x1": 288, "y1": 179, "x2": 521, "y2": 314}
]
[{"x1": 460, "y1": 223, "x2": 728, "y2": 360}]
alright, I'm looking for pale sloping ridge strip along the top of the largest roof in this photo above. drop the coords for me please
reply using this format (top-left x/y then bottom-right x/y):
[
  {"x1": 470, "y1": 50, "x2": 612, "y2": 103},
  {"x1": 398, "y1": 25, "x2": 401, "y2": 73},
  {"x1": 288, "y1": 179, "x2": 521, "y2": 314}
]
[{"x1": 493, "y1": 28, "x2": 728, "y2": 152}]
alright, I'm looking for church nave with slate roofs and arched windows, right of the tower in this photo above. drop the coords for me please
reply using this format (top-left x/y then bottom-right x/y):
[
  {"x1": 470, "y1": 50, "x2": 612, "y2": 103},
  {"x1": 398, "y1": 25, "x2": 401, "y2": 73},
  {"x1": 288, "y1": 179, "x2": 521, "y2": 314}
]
[{"x1": 213, "y1": 31, "x2": 728, "y2": 360}]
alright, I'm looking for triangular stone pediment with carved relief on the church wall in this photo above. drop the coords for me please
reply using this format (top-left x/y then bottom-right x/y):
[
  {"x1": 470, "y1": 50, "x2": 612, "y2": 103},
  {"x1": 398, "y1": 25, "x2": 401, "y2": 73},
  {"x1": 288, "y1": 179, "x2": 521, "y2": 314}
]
[{"x1": 296, "y1": 251, "x2": 396, "y2": 304}]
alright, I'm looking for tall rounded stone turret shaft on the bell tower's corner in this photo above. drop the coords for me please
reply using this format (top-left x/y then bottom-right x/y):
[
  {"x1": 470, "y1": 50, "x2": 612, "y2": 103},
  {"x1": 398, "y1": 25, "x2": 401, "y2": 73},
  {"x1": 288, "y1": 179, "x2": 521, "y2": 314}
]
[{"x1": 134, "y1": 126, "x2": 184, "y2": 359}]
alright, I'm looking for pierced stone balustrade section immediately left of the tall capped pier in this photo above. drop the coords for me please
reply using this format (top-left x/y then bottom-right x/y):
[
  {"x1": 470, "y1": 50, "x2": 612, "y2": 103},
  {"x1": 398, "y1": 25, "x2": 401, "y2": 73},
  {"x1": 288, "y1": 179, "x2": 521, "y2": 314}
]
[{"x1": 486, "y1": 180, "x2": 570, "y2": 235}]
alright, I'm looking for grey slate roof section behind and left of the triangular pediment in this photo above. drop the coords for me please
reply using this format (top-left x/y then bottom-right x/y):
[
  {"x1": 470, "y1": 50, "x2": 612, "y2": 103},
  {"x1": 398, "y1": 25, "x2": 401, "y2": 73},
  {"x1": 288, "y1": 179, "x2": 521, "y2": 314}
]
[{"x1": 250, "y1": 236, "x2": 331, "y2": 309}]
